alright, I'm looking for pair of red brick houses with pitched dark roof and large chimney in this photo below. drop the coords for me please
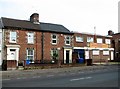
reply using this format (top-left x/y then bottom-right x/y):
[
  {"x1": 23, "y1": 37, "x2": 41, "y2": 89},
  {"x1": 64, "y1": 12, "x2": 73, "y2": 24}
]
[{"x1": 1, "y1": 13, "x2": 73, "y2": 69}]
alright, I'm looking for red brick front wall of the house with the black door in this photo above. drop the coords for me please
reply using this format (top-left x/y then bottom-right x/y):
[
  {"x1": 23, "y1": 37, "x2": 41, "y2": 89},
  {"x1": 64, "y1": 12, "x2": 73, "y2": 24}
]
[{"x1": 44, "y1": 32, "x2": 72, "y2": 60}]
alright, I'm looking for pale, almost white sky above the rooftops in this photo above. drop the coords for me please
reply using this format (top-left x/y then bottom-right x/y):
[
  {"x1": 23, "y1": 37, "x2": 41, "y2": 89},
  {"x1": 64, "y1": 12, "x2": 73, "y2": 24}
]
[{"x1": 0, "y1": 0, "x2": 120, "y2": 35}]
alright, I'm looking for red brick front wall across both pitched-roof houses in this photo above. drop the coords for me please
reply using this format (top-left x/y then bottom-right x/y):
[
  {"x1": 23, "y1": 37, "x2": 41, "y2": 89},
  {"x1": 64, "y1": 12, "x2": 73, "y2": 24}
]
[{"x1": 5, "y1": 29, "x2": 72, "y2": 61}]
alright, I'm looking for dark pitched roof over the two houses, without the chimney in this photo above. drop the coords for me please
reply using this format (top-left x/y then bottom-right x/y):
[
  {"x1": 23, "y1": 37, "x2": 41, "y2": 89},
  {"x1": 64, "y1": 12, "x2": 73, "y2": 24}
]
[{"x1": 1, "y1": 17, "x2": 72, "y2": 34}]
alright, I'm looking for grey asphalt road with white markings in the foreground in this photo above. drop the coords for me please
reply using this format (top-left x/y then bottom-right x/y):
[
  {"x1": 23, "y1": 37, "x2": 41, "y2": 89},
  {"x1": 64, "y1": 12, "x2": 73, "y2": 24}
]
[{"x1": 2, "y1": 67, "x2": 119, "y2": 87}]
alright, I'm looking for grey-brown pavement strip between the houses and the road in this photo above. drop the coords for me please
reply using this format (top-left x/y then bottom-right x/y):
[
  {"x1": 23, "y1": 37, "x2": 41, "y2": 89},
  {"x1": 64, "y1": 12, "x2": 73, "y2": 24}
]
[{"x1": 1, "y1": 65, "x2": 117, "y2": 79}]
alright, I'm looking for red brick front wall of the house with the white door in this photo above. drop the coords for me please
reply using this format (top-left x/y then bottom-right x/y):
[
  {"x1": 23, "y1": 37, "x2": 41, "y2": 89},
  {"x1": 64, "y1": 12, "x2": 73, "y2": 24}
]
[{"x1": 5, "y1": 29, "x2": 41, "y2": 61}]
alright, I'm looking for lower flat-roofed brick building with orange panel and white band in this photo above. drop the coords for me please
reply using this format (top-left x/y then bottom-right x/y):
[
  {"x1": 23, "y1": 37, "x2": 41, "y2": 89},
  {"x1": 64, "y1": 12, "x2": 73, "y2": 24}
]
[{"x1": 73, "y1": 33, "x2": 114, "y2": 63}]
